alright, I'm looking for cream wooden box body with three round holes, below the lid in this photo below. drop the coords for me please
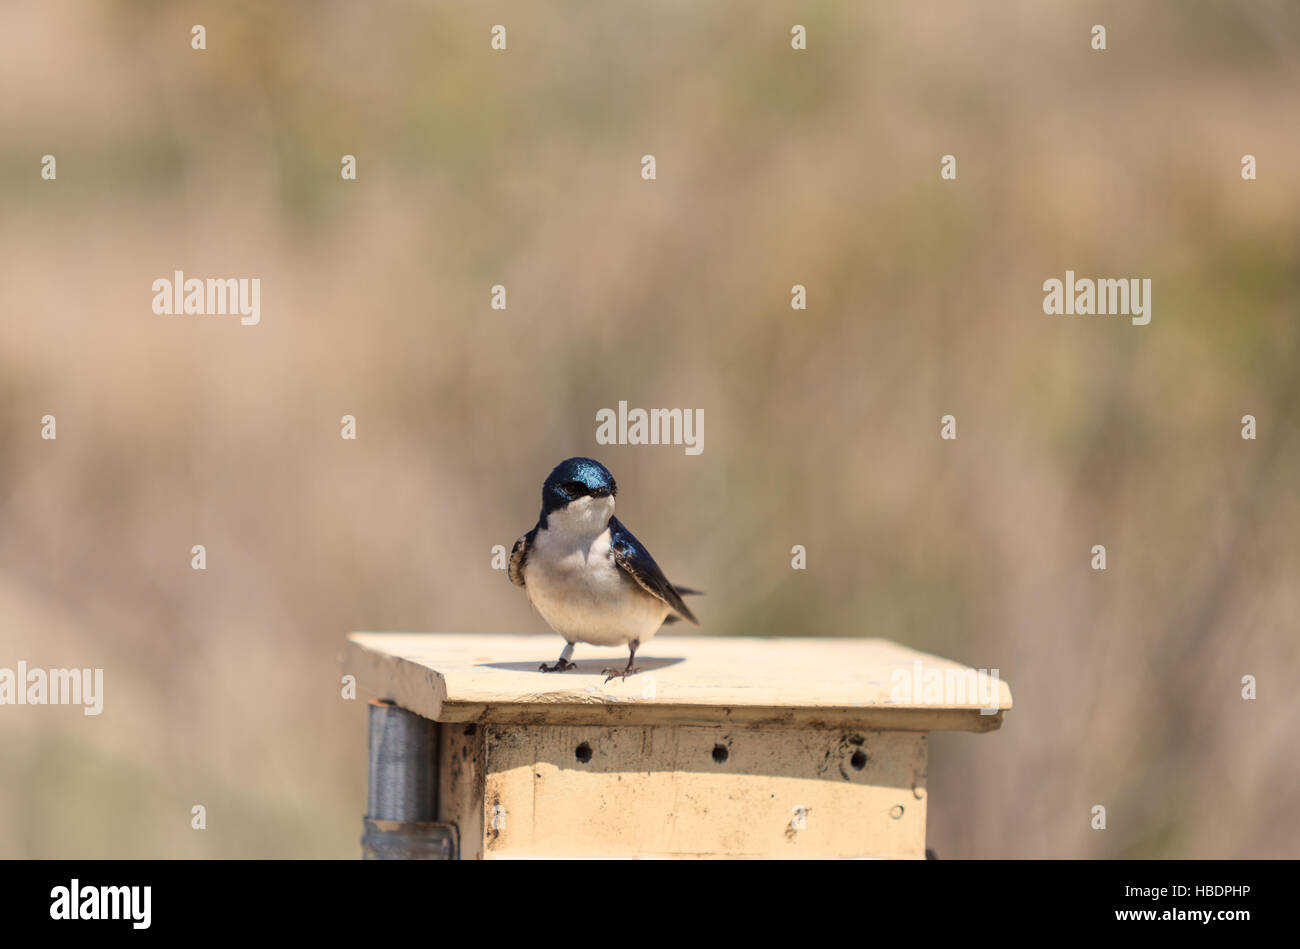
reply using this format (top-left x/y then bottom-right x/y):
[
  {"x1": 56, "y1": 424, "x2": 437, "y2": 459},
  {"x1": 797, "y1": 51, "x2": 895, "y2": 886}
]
[{"x1": 452, "y1": 724, "x2": 928, "y2": 859}]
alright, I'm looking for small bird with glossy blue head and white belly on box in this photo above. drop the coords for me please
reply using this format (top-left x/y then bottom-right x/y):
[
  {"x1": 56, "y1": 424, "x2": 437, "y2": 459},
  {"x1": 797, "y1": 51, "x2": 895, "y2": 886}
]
[{"x1": 510, "y1": 458, "x2": 699, "y2": 681}]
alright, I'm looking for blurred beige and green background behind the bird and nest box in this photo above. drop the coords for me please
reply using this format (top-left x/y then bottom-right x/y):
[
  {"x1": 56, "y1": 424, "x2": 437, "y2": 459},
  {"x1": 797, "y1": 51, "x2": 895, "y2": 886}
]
[{"x1": 0, "y1": 0, "x2": 1300, "y2": 857}]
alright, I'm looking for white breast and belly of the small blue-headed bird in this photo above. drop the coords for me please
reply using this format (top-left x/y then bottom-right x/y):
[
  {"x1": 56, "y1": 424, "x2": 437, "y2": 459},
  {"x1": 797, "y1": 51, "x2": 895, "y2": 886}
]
[{"x1": 524, "y1": 517, "x2": 670, "y2": 646}]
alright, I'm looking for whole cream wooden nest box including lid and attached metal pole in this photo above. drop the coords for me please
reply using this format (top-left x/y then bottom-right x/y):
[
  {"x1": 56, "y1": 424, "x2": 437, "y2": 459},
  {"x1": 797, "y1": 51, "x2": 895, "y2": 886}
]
[{"x1": 345, "y1": 633, "x2": 1011, "y2": 859}]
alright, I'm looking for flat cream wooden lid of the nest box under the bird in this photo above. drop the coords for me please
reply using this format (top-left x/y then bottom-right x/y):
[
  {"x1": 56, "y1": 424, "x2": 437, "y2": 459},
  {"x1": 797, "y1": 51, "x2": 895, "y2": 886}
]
[{"x1": 343, "y1": 633, "x2": 1011, "y2": 732}]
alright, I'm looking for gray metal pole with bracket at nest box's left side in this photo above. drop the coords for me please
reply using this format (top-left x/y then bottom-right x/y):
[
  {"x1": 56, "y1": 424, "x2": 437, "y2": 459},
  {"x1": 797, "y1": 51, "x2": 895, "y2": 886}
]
[{"x1": 361, "y1": 701, "x2": 458, "y2": 861}]
